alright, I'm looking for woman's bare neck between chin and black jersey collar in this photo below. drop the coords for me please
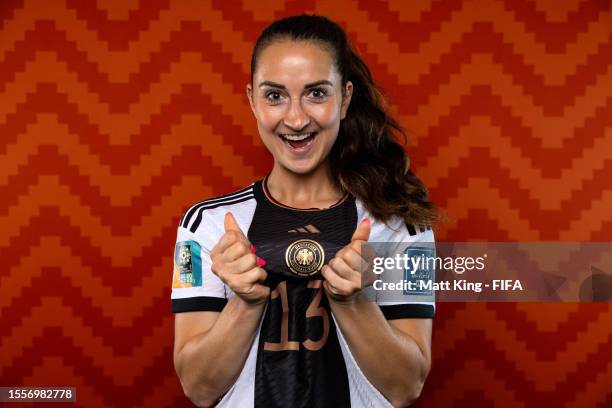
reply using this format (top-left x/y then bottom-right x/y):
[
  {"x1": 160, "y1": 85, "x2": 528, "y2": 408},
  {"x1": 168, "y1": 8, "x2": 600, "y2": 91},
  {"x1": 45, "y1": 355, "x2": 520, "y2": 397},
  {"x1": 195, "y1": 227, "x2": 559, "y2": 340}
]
[{"x1": 267, "y1": 163, "x2": 344, "y2": 208}]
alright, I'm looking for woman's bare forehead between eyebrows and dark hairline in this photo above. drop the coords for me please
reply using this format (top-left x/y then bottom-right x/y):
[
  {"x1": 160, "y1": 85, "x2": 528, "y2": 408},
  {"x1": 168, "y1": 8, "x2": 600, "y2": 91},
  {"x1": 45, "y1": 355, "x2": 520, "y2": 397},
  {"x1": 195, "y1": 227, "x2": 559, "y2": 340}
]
[{"x1": 253, "y1": 40, "x2": 340, "y2": 86}]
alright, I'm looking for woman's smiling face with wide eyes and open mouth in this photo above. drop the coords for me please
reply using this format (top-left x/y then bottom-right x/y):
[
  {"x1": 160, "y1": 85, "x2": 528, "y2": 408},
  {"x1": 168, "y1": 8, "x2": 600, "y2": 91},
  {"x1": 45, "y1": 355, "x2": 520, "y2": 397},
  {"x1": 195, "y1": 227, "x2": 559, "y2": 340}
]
[{"x1": 247, "y1": 40, "x2": 353, "y2": 174}]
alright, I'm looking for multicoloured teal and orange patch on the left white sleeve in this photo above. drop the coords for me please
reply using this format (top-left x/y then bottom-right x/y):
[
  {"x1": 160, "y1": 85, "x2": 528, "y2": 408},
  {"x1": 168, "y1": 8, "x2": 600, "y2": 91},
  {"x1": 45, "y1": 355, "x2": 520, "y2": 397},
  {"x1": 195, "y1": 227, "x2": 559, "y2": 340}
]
[{"x1": 172, "y1": 241, "x2": 202, "y2": 288}]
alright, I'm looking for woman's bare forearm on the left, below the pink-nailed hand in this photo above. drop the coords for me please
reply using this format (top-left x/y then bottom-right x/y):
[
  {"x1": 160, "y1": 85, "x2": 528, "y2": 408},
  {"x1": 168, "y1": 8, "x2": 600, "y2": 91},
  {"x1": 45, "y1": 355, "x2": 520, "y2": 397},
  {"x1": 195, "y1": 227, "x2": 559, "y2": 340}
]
[{"x1": 176, "y1": 296, "x2": 265, "y2": 406}]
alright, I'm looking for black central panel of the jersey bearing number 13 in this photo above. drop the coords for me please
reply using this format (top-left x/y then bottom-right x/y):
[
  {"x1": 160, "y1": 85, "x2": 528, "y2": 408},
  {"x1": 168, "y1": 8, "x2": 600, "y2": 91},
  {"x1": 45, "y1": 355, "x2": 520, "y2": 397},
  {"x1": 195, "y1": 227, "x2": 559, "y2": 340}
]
[{"x1": 248, "y1": 182, "x2": 357, "y2": 408}]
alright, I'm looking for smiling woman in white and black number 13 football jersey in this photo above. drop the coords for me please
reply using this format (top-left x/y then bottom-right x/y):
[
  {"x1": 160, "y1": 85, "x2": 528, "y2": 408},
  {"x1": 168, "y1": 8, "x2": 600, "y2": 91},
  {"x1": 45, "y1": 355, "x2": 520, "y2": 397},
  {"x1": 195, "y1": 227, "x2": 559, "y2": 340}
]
[{"x1": 172, "y1": 15, "x2": 436, "y2": 407}]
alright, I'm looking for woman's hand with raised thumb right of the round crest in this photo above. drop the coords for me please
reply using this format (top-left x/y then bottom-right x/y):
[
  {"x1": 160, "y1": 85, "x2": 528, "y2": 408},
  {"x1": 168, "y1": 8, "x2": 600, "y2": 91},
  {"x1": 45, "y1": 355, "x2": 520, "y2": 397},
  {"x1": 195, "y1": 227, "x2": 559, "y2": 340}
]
[{"x1": 321, "y1": 218, "x2": 374, "y2": 302}]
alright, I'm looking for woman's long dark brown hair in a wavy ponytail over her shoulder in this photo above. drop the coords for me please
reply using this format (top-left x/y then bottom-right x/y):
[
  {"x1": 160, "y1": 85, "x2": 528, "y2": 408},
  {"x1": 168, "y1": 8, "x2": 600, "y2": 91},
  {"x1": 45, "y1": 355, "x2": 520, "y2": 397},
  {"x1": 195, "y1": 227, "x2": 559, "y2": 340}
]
[{"x1": 251, "y1": 14, "x2": 440, "y2": 225}]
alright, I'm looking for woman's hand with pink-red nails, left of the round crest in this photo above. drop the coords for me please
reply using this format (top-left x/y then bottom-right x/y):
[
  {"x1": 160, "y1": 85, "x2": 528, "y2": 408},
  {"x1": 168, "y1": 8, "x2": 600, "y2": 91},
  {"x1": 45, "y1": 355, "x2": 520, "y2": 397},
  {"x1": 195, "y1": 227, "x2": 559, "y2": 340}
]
[{"x1": 210, "y1": 212, "x2": 270, "y2": 304}]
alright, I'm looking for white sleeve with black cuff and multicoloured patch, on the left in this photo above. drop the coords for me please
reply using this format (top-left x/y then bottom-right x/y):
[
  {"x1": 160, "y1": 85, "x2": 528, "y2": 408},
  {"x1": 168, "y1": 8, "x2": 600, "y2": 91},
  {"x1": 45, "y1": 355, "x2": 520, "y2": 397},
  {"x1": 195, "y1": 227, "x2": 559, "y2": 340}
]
[{"x1": 171, "y1": 226, "x2": 227, "y2": 313}]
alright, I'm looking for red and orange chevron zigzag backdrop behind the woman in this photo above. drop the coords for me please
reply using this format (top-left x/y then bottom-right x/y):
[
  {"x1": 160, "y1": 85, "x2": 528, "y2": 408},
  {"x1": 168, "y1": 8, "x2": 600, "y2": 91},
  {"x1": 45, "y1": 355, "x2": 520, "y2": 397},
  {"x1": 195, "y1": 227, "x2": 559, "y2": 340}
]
[{"x1": 0, "y1": 0, "x2": 612, "y2": 407}]
